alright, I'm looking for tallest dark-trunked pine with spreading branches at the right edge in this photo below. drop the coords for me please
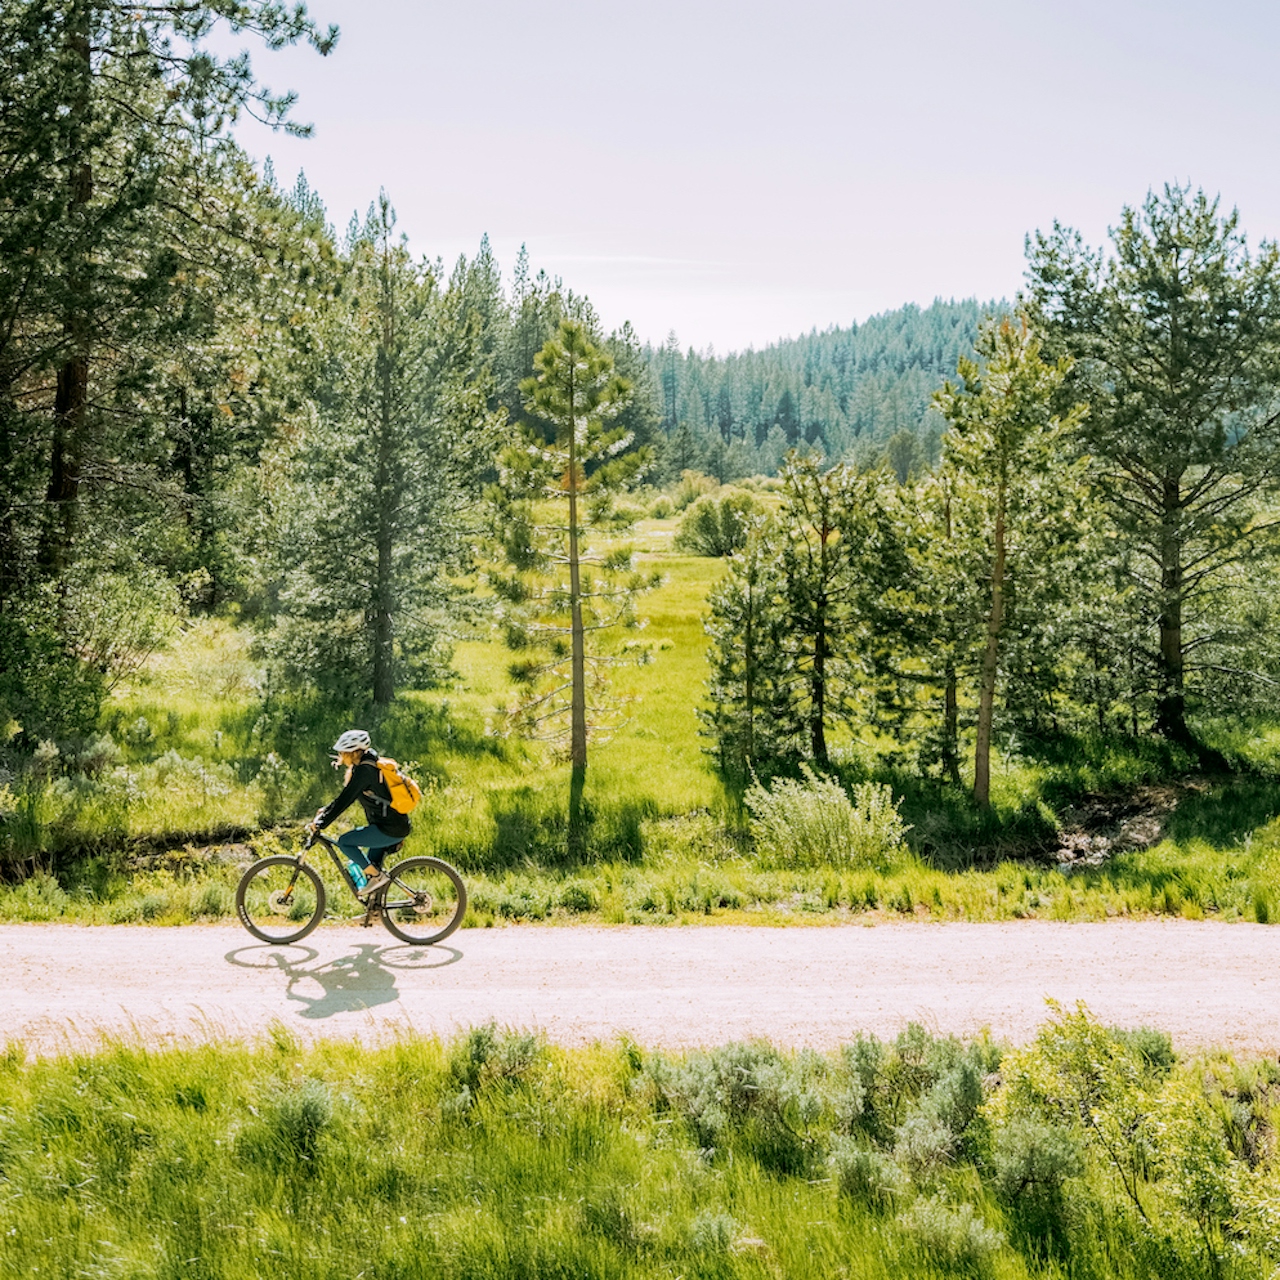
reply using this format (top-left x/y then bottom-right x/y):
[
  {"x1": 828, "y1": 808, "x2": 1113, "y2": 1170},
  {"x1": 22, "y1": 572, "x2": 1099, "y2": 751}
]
[{"x1": 1028, "y1": 186, "x2": 1280, "y2": 759}]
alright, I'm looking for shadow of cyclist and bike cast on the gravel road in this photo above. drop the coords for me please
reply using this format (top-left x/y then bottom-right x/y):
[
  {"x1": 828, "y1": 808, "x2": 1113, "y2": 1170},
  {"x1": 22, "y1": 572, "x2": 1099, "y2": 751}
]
[{"x1": 225, "y1": 942, "x2": 462, "y2": 1019}]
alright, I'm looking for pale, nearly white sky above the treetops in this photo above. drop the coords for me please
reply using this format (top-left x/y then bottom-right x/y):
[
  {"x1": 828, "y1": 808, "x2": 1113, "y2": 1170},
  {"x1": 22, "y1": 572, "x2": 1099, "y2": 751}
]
[{"x1": 225, "y1": 0, "x2": 1280, "y2": 353}]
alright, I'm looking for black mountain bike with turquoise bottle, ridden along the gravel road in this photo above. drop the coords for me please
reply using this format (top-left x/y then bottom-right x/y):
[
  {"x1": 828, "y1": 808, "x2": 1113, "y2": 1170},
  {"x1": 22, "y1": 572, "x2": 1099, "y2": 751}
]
[{"x1": 236, "y1": 831, "x2": 467, "y2": 946}]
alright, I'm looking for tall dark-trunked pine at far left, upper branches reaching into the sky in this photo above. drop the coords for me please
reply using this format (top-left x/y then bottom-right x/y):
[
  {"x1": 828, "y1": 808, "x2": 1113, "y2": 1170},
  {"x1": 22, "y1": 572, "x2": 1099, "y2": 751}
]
[{"x1": 23, "y1": 0, "x2": 337, "y2": 576}]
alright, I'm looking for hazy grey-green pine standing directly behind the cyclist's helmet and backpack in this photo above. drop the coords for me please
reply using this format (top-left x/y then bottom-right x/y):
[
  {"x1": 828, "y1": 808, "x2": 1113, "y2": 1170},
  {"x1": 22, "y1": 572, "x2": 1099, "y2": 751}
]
[{"x1": 268, "y1": 195, "x2": 499, "y2": 708}]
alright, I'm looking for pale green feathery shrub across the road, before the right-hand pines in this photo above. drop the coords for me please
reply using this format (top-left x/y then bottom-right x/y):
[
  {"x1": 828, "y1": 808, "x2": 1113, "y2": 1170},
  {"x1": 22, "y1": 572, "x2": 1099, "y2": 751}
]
[{"x1": 744, "y1": 764, "x2": 910, "y2": 869}]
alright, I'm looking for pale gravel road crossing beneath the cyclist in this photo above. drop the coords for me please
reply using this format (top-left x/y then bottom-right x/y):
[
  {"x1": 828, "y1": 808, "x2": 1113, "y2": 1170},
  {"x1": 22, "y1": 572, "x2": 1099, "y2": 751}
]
[{"x1": 0, "y1": 920, "x2": 1280, "y2": 1053}]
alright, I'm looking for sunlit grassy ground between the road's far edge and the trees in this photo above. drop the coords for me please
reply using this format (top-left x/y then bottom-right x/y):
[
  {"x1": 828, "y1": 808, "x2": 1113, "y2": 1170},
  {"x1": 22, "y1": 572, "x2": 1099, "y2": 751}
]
[{"x1": 0, "y1": 521, "x2": 1280, "y2": 925}]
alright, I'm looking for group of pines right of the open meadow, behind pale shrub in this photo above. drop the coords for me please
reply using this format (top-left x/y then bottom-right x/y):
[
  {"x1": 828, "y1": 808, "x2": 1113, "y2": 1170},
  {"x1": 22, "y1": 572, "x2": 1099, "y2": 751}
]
[{"x1": 705, "y1": 187, "x2": 1280, "y2": 805}]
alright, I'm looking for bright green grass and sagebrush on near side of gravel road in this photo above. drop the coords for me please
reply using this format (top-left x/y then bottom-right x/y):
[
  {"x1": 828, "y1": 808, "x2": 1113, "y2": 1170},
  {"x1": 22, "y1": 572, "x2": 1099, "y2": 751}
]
[{"x1": 0, "y1": 1015, "x2": 1280, "y2": 1280}]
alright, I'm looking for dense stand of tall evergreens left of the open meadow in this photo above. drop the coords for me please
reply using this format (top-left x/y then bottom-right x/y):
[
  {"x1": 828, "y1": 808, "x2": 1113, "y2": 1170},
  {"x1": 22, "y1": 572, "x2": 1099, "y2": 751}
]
[{"x1": 0, "y1": 0, "x2": 659, "y2": 749}]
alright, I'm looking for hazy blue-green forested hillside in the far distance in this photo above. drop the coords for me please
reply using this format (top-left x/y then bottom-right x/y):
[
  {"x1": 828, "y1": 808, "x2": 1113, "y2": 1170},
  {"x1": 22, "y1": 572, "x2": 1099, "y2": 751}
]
[{"x1": 644, "y1": 300, "x2": 1007, "y2": 483}]
